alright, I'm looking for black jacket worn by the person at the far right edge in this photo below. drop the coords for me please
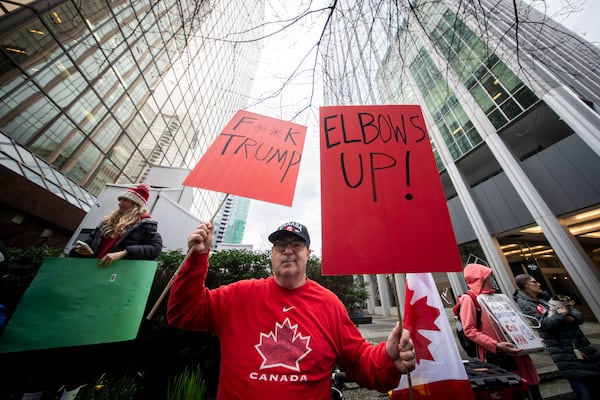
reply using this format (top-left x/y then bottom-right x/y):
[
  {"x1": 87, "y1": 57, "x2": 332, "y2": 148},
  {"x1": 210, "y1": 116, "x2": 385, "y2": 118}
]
[{"x1": 513, "y1": 290, "x2": 600, "y2": 379}]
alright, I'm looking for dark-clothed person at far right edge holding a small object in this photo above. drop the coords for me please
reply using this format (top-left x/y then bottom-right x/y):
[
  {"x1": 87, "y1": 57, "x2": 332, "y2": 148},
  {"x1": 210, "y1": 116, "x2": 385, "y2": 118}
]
[{"x1": 513, "y1": 274, "x2": 600, "y2": 400}]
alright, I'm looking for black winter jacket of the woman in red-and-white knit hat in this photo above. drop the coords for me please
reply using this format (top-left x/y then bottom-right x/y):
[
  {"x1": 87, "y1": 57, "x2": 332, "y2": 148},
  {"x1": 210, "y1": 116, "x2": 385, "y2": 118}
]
[{"x1": 69, "y1": 218, "x2": 162, "y2": 260}]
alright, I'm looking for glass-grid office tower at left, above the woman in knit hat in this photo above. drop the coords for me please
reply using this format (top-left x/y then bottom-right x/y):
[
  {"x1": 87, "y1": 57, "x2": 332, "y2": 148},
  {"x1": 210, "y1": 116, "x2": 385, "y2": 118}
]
[{"x1": 0, "y1": 0, "x2": 264, "y2": 246}]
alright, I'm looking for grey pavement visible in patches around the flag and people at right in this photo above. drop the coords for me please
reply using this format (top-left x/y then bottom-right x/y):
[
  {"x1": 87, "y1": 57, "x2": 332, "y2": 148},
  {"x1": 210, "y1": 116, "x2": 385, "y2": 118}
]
[{"x1": 358, "y1": 309, "x2": 600, "y2": 400}]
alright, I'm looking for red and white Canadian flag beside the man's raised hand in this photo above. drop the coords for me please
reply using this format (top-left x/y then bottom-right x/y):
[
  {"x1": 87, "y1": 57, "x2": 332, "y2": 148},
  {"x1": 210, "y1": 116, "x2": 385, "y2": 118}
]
[{"x1": 390, "y1": 273, "x2": 475, "y2": 400}]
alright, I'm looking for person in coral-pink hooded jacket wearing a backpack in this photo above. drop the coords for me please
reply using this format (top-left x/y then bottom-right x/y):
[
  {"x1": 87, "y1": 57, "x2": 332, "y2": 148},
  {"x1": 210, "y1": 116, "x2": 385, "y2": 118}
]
[{"x1": 460, "y1": 264, "x2": 542, "y2": 400}]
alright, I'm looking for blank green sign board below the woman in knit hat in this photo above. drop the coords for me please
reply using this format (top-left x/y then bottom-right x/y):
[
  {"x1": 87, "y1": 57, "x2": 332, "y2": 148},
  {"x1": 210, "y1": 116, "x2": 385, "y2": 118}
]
[{"x1": 0, "y1": 258, "x2": 157, "y2": 353}]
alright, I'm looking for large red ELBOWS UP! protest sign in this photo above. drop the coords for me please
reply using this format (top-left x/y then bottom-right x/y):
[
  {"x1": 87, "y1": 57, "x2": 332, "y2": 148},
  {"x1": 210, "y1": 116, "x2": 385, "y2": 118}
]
[{"x1": 320, "y1": 105, "x2": 462, "y2": 275}]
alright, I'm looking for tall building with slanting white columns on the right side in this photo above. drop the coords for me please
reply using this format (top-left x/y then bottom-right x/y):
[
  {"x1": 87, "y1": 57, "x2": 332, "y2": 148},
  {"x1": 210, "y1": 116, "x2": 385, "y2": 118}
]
[{"x1": 323, "y1": 0, "x2": 600, "y2": 320}]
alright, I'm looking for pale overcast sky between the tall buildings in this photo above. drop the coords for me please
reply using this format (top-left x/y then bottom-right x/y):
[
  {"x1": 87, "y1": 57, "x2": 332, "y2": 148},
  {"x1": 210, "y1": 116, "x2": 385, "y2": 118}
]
[{"x1": 243, "y1": 0, "x2": 600, "y2": 257}]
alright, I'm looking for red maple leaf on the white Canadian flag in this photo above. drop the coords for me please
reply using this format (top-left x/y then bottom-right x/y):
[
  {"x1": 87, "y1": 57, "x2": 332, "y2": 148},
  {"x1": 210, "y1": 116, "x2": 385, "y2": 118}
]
[{"x1": 403, "y1": 287, "x2": 440, "y2": 364}]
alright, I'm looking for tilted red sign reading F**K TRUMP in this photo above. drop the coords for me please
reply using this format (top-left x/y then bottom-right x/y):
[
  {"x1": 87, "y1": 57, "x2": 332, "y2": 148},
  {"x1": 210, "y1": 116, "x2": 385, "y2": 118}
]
[{"x1": 183, "y1": 110, "x2": 306, "y2": 206}]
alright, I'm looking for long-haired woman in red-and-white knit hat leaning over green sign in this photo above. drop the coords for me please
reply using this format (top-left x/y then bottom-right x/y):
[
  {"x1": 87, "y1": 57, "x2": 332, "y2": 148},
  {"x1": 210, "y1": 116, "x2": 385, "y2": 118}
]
[{"x1": 69, "y1": 183, "x2": 162, "y2": 267}]
